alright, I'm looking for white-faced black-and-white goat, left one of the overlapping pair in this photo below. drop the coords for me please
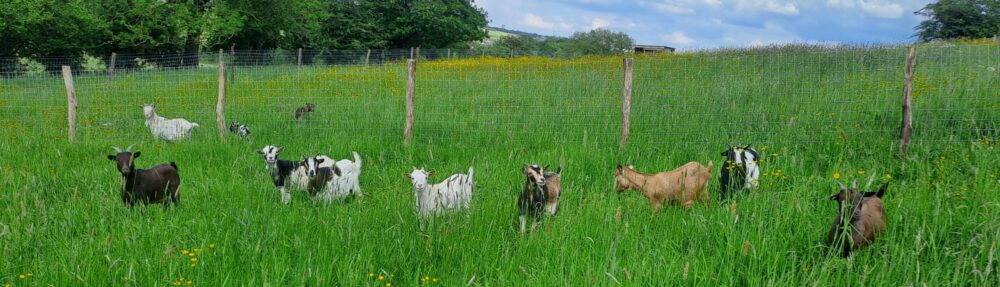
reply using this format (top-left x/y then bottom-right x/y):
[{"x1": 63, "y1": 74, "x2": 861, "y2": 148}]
[{"x1": 257, "y1": 145, "x2": 333, "y2": 204}]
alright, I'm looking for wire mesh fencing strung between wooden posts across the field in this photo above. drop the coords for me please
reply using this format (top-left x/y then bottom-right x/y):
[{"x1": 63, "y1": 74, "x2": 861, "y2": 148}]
[{"x1": 0, "y1": 42, "x2": 1000, "y2": 152}]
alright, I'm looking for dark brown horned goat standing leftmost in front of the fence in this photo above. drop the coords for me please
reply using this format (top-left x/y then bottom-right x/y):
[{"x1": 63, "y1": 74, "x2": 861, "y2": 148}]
[{"x1": 108, "y1": 145, "x2": 181, "y2": 207}]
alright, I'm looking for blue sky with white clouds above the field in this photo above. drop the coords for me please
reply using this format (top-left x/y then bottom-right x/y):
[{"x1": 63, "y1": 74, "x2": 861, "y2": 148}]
[{"x1": 474, "y1": 0, "x2": 930, "y2": 50}]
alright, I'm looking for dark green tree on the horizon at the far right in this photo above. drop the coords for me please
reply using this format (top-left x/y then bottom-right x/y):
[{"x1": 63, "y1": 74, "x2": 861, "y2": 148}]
[{"x1": 913, "y1": 0, "x2": 1000, "y2": 42}]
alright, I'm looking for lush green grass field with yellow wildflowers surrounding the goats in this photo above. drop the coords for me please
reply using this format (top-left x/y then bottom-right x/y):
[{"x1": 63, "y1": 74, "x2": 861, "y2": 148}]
[{"x1": 0, "y1": 43, "x2": 1000, "y2": 286}]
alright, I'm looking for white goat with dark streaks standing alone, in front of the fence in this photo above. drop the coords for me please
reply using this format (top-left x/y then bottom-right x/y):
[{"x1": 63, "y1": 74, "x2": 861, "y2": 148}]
[{"x1": 403, "y1": 166, "x2": 475, "y2": 217}]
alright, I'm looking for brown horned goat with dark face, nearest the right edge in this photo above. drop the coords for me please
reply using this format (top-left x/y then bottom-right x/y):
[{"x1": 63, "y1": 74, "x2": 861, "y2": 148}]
[{"x1": 826, "y1": 179, "x2": 889, "y2": 257}]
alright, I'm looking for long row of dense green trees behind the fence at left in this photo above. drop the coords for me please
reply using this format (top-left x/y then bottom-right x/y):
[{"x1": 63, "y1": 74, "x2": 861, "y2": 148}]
[{"x1": 0, "y1": 0, "x2": 486, "y2": 57}]
